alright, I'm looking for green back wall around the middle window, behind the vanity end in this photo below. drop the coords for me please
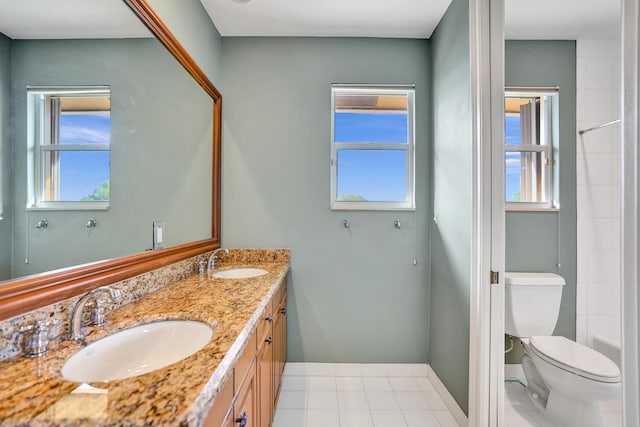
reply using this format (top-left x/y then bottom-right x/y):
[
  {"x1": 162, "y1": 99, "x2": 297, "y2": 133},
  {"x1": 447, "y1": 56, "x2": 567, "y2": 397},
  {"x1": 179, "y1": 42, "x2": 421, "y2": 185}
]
[{"x1": 220, "y1": 37, "x2": 431, "y2": 363}]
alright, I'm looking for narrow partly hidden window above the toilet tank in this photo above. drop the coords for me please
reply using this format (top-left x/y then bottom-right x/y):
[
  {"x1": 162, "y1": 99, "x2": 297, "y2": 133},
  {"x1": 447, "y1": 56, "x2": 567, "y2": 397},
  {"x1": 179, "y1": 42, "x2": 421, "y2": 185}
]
[{"x1": 504, "y1": 89, "x2": 558, "y2": 209}]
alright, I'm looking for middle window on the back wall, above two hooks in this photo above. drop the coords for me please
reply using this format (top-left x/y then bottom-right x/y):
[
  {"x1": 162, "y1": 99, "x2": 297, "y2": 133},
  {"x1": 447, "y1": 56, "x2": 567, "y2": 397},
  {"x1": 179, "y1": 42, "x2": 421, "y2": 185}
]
[{"x1": 331, "y1": 85, "x2": 415, "y2": 210}]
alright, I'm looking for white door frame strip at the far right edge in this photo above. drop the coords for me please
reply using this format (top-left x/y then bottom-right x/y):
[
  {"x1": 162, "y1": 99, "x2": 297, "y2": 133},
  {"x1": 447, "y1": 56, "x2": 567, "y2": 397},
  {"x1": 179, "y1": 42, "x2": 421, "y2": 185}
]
[{"x1": 620, "y1": 0, "x2": 640, "y2": 427}]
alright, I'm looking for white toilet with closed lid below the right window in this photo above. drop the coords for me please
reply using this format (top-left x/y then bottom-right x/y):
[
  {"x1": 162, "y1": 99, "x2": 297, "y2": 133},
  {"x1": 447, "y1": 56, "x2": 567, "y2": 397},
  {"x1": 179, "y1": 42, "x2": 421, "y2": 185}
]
[{"x1": 505, "y1": 272, "x2": 620, "y2": 427}]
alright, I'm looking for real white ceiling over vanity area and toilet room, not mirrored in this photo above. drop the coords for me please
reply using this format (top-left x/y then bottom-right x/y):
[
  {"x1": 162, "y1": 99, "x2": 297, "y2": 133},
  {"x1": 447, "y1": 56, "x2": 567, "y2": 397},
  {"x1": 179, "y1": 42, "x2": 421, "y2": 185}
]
[{"x1": 200, "y1": 0, "x2": 620, "y2": 40}]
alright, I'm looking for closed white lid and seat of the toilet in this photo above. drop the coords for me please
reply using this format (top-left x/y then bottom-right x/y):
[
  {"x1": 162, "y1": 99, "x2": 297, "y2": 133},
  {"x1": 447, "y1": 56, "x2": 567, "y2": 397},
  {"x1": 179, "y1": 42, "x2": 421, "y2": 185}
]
[{"x1": 529, "y1": 336, "x2": 620, "y2": 383}]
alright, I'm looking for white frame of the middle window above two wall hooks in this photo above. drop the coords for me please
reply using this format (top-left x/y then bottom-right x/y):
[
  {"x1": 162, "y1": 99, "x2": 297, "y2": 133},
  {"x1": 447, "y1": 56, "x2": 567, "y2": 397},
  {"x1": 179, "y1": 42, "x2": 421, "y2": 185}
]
[{"x1": 330, "y1": 84, "x2": 415, "y2": 211}]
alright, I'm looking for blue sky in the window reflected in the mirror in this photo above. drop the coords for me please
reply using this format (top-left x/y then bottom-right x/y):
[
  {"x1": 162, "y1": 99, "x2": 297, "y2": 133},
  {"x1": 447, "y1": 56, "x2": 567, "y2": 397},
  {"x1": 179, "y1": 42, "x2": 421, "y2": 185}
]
[{"x1": 60, "y1": 114, "x2": 111, "y2": 201}]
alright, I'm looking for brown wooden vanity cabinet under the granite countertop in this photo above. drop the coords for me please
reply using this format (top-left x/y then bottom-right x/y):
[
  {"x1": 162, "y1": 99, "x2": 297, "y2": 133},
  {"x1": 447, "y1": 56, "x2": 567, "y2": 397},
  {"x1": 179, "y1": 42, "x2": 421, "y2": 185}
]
[{"x1": 204, "y1": 281, "x2": 287, "y2": 427}]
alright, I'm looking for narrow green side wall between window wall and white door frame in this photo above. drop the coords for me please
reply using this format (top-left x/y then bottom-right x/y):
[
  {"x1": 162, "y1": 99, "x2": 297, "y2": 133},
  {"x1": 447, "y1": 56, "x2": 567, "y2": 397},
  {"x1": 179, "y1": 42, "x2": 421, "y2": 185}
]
[{"x1": 429, "y1": 0, "x2": 472, "y2": 412}]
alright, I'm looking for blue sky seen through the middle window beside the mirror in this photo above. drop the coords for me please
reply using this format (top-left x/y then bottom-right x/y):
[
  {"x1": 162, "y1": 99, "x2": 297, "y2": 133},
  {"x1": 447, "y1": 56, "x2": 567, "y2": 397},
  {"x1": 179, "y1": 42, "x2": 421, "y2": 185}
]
[{"x1": 334, "y1": 112, "x2": 408, "y2": 201}]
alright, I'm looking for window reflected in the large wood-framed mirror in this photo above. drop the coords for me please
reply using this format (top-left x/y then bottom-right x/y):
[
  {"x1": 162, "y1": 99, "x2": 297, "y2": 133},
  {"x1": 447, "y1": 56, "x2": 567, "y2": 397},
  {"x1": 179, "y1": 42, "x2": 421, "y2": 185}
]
[{"x1": 27, "y1": 87, "x2": 111, "y2": 209}]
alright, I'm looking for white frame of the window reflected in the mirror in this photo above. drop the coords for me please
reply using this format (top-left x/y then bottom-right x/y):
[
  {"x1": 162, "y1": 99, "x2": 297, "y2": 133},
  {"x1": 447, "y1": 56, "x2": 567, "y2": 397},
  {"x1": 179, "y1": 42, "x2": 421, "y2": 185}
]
[{"x1": 27, "y1": 86, "x2": 111, "y2": 210}]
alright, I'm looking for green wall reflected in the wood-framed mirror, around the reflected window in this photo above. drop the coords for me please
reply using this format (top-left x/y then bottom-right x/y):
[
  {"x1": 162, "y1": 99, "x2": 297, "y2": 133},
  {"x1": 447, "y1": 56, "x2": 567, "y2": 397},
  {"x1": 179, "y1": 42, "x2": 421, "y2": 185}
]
[{"x1": 6, "y1": 39, "x2": 213, "y2": 277}]
